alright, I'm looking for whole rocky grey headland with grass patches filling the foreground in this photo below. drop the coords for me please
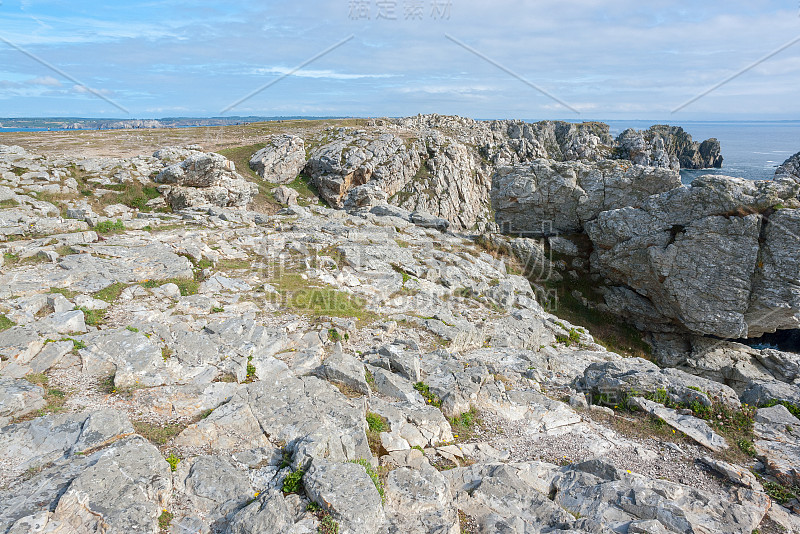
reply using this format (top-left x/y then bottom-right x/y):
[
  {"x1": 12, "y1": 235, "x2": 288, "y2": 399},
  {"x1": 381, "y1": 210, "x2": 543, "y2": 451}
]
[{"x1": 0, "y1": 115, "x2": 800, "y2": 534}]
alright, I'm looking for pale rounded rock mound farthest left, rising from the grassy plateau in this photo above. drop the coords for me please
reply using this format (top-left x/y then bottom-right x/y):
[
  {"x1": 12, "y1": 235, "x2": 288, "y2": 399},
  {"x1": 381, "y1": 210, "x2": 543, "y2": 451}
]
[{"x1": 155, "y1": 153, "x2": 258, "y2": 210}]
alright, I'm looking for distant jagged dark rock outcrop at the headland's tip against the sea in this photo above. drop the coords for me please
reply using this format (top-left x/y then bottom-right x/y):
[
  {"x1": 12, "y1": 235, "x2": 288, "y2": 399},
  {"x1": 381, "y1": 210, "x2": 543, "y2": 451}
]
[{"x1": 616, "y1": 125, "x2": 723, "y2": 170}]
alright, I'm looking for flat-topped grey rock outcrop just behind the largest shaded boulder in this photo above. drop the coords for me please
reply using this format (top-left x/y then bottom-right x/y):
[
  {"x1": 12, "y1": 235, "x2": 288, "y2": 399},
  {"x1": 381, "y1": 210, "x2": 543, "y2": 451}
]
[{"x1": 491, "y1": 159, "x2": 681, "y2": 235}]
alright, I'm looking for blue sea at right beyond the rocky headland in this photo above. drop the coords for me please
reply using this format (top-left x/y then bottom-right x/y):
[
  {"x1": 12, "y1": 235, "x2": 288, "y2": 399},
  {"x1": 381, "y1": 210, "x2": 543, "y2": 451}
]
[{"x1": 602, "y1": 121, "x2": 800, "y2": 183}]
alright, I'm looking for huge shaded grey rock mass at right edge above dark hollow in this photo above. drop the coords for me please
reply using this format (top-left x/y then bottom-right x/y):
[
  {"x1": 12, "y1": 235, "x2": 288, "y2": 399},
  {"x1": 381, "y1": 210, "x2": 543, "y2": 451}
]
[{"x1": 586, "y1": 176, "x2": 800, "y2": 339}]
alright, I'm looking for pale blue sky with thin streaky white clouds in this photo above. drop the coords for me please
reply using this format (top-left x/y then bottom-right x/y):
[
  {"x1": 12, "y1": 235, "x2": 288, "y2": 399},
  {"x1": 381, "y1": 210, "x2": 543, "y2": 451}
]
[{"x1": 0, "y1": 0, "x2": 800, "y2": 122}]
